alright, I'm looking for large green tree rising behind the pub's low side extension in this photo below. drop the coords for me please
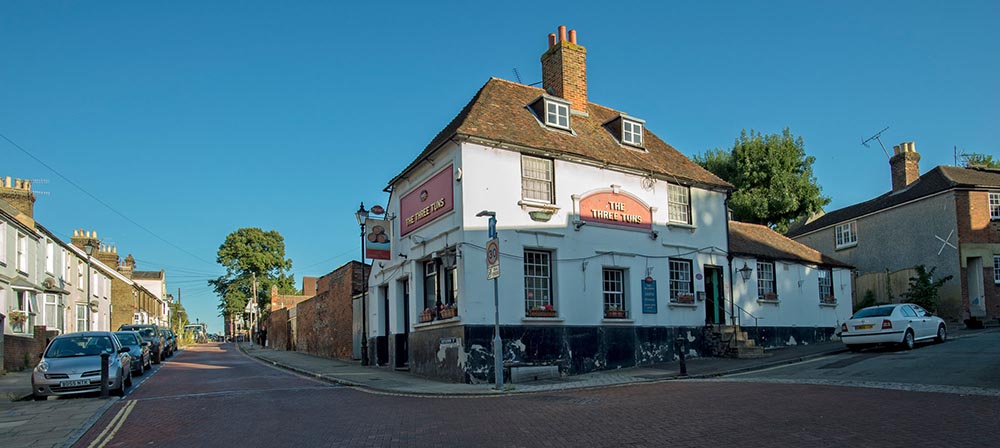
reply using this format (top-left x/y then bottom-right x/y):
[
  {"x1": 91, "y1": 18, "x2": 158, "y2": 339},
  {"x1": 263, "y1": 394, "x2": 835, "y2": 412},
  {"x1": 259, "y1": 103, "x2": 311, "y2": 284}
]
[{"x1": 694, "y1": 128, "x2": 830, "y2": 233}]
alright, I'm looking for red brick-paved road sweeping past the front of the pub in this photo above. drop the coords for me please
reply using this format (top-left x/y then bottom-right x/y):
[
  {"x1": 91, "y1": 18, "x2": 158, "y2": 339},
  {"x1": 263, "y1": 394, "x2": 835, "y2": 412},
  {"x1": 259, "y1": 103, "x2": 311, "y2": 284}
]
[{"x1": 76, "y1": 345, "x2": 1000, "y2": 448}]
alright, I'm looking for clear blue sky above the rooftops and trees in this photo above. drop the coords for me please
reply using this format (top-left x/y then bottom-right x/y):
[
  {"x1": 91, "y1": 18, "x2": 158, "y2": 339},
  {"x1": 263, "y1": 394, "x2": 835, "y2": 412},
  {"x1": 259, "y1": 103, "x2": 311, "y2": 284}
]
[{"x1": 0, "y1": 0, "x2": 1000, "y2": 332}]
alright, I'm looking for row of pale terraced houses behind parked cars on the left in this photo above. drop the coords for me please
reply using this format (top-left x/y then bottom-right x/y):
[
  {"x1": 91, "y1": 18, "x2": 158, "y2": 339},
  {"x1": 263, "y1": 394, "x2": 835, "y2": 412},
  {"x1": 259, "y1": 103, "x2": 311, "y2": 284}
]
[{"x1": 0, "y1": 177, "x2": 172, "y2": 371}]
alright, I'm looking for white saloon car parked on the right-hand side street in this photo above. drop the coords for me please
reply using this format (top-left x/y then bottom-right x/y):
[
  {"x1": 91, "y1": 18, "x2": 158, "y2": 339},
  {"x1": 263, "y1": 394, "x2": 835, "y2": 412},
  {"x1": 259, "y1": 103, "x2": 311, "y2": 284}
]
[{"x1": 840, "y1": 303, "x2": 948, "y2": 351}]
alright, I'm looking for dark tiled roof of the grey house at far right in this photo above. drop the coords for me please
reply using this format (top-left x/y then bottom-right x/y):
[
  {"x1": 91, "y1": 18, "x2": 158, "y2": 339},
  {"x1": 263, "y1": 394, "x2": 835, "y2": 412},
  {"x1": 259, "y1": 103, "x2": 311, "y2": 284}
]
[{"x1": 787, "y1": 165, "x2": 1000, "y2": 238}]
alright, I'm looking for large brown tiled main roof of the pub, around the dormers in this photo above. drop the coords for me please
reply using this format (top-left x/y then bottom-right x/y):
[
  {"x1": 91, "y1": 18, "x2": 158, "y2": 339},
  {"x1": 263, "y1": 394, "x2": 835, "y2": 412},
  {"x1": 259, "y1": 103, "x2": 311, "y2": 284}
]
[{"x1": 389, "y1": 78, "x2": 732, "y2": 190}]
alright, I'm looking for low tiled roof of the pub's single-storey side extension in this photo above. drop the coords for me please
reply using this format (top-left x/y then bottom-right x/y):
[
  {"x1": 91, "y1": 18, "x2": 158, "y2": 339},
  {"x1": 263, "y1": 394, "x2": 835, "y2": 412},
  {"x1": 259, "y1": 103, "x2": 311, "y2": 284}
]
[{"x1": 729, "y1": 221, "x2": 852, "y2": 268}]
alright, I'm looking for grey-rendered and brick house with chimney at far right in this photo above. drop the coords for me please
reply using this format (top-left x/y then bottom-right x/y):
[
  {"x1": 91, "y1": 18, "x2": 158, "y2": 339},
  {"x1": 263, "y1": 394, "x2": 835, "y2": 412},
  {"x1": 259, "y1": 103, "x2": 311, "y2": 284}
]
[{"x1": 788, "y1": 142, "x2": 1000, "y2": 320}]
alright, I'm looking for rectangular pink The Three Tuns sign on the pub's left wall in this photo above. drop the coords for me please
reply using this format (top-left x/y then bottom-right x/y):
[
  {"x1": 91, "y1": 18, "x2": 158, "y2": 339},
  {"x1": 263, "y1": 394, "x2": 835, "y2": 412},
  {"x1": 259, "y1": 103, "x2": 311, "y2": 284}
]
[{"x1": 399, "y1": 165, "x2": 455, "y2": 236}]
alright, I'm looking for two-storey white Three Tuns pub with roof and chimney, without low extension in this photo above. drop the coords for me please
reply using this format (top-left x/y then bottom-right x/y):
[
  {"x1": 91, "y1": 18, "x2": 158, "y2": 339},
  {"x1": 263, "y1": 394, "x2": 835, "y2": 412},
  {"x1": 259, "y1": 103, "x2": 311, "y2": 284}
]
[{"x1": 367, "y1": 27, "x2": 848, "y2": 383}]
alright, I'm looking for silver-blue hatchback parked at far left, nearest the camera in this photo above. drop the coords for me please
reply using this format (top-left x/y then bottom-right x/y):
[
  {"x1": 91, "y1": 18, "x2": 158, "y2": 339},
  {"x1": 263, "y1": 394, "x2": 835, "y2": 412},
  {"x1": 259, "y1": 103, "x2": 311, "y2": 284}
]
[{"x1": 31, "y1": 331, "x2": 132, "y2": 400}]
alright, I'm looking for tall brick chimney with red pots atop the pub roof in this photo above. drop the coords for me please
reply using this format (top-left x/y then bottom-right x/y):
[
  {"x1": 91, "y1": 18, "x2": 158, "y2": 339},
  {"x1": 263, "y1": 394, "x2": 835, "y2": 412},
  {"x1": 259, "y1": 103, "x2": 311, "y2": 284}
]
[{"x1": 542, "y1": 25, "x2": 587, "y2": 111}]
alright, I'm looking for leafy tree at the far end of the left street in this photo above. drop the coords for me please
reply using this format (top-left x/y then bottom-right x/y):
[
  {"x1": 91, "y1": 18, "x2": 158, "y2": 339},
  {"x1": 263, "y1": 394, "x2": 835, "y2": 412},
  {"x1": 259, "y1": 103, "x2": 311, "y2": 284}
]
[{"x1": 208, "y1": 227, "x2": 297, "y2": 316}]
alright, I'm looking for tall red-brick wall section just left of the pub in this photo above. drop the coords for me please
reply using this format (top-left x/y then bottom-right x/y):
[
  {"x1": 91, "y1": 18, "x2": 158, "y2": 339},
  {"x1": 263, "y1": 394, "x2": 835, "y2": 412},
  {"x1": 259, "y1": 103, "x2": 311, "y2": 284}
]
[{"x1": 296, "y1": 261, "x2": 368, "y2": 359}]
